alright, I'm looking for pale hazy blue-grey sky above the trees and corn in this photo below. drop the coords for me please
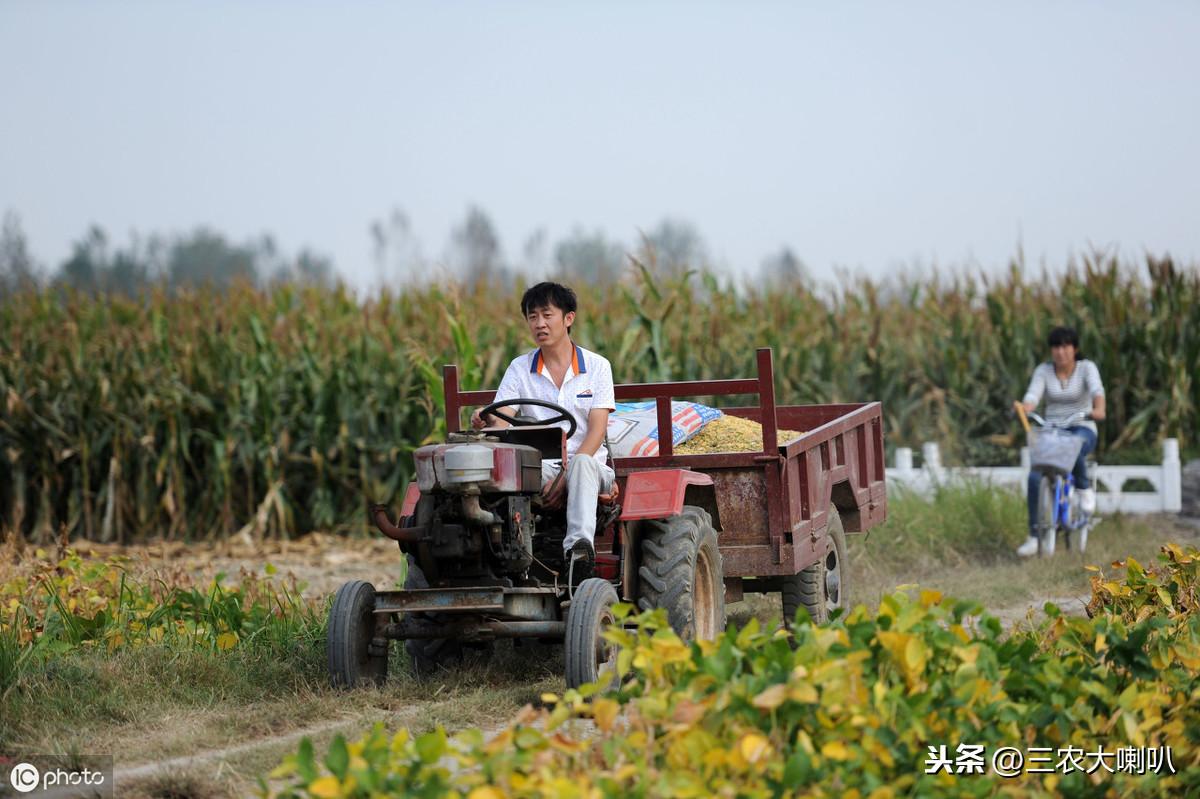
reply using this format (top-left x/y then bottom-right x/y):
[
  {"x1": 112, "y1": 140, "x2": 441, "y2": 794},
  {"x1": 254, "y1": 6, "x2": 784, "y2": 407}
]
[{"x1": 0, "y1": 0, "x2": 1200, "y2": 284}]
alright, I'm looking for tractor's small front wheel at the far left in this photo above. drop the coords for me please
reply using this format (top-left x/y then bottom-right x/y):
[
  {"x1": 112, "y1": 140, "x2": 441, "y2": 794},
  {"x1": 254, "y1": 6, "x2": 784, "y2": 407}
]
[{"x1": 325, "y1": 579, "x2": 389, "y2": 687}]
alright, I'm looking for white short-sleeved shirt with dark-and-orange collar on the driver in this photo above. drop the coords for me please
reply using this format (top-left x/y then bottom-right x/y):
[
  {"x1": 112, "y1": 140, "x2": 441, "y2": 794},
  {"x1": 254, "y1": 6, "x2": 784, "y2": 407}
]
[{"x1": 496, "y1": 344, "x2": 617, "y2": 463}]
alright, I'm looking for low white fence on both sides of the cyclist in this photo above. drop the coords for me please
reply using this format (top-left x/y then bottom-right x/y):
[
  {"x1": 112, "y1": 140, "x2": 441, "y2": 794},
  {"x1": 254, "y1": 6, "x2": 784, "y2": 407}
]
[{"x1": 887, "y1": 438, "x2": 1183, "y2": 513}]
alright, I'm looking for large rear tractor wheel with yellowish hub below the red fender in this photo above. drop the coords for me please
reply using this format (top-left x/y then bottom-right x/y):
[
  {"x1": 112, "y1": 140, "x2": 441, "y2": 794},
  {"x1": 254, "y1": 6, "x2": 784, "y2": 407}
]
[{"x1": 637, "y1": 505, "x2": 725, "y2": 641}]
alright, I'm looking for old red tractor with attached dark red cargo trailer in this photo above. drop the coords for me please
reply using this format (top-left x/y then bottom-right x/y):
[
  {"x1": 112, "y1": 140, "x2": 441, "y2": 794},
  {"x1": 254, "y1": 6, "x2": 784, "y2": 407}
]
[{"x1": 328, "y1": 348, "x2": 887, "y2": 686}]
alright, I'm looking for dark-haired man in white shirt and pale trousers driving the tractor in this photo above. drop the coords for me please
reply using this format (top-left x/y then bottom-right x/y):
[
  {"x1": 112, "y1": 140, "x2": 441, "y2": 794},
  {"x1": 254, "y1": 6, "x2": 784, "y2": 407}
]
[{"x1": 470, "y1": 282, "x2": 617, "y2": 583}]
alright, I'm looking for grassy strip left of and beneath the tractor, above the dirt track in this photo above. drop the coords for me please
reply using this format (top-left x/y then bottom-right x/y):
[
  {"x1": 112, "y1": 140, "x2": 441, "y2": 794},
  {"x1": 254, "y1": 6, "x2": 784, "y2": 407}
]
[{"x1": 0, "y1": 597, "x2": 563, "y2": 765}]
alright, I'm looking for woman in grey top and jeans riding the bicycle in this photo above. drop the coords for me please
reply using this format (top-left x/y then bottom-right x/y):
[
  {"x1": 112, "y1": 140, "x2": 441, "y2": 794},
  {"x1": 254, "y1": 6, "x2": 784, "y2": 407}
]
[{"x1": 1016, "y1": 328, "x2": 1104, "y2": 558}]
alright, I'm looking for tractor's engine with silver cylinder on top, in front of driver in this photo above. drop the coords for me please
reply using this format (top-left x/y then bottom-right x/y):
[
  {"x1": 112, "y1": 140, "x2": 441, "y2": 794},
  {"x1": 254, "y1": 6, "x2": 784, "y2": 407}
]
[{"x1": 409, "y1": 433, "x2": 541, "y2": 579}]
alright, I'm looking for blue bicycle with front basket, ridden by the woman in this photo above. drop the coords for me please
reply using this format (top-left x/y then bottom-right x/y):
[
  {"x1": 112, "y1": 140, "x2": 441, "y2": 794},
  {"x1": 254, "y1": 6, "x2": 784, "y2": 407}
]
[{"x1": 1028, "y1": 411, "x2": 1094, "y2": 558}]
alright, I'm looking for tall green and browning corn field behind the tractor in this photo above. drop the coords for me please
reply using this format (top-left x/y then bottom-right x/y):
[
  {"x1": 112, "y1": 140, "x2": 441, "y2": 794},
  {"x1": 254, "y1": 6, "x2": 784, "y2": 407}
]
[{"x1": 0, "y1": 251, "x2": 1200, "y2": 541}]
